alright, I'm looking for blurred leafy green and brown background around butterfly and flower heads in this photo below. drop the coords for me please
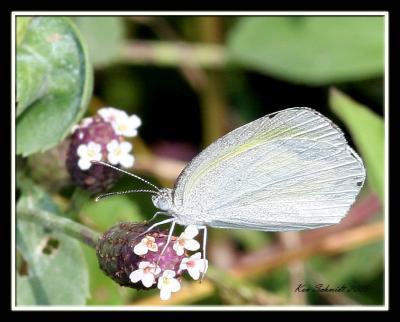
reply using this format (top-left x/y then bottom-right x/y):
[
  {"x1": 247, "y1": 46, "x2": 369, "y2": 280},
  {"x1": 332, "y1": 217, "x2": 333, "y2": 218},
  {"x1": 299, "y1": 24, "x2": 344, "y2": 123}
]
[{"x1": 16, "y1": 16, "x2": 384, "y2": 305}]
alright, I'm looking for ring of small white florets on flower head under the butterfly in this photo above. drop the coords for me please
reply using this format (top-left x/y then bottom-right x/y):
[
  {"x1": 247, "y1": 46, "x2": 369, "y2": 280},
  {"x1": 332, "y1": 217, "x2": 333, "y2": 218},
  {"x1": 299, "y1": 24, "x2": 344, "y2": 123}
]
[{"x1": 129, "y1": 225, "x2": 207, "y2": 300}]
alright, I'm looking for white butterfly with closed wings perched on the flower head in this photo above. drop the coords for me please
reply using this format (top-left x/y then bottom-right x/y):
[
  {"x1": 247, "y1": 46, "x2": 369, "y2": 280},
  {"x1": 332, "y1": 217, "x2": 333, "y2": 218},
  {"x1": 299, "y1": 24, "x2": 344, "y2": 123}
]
[{"x1": 93, "y1": 107, "x2": 365, "y2": 276}]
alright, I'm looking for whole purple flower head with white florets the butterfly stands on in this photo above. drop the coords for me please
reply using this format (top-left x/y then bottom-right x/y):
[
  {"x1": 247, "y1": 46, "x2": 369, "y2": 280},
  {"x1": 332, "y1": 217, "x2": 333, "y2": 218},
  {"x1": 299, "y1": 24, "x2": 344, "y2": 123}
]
[{"x1": 96, "y1": 222, "x2": 207, "y2": 300}]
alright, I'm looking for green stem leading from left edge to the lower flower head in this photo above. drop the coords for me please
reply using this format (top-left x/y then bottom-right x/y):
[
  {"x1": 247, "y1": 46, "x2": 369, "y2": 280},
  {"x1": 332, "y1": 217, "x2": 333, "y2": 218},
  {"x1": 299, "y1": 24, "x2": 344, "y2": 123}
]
[{"x1": 17, "y1": 208, "x2": 100, "y2": 248}]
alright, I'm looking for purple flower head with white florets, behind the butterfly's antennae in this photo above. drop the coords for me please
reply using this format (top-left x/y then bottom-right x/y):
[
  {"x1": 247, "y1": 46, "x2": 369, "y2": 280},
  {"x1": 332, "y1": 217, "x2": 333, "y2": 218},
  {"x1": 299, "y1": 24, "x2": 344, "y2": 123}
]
[{"x1": 67, "y1": 107, "x2": 141, "y2": 193}]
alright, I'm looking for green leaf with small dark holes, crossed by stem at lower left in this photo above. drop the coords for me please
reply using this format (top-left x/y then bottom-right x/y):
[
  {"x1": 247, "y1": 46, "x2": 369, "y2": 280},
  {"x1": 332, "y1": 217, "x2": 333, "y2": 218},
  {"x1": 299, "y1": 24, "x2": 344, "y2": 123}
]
[{"x1": 16, "y1": 183, "x2": 89, "y2": 305}]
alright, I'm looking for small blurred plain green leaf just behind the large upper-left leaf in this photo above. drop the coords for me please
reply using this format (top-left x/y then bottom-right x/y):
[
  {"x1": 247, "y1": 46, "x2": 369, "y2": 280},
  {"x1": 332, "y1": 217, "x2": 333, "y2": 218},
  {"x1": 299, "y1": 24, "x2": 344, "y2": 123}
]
[{"x1": 75, "y1": 17, "x2": 125, "y2": 67}]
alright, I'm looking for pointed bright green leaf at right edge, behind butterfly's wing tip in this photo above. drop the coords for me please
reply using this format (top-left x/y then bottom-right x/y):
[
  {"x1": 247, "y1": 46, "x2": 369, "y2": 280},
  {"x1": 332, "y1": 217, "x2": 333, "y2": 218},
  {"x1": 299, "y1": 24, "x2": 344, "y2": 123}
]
[{"x1": 329, "y1": 89, "x2": 385, "y2": 202}]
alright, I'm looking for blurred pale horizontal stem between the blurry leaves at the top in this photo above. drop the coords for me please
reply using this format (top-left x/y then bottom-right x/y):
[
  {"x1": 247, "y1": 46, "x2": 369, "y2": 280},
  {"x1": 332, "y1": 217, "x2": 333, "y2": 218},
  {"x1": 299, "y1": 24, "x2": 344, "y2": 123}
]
[{"x1": 120, "y1": 40, "x2": 228, "y2": 69}]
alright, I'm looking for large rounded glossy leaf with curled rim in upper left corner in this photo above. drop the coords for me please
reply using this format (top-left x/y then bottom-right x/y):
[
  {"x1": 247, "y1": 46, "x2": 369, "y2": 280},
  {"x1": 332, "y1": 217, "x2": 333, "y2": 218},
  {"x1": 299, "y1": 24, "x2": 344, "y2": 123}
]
[{"x1": 16, "y1": 17, "x2": 93, "y2": 156}]
